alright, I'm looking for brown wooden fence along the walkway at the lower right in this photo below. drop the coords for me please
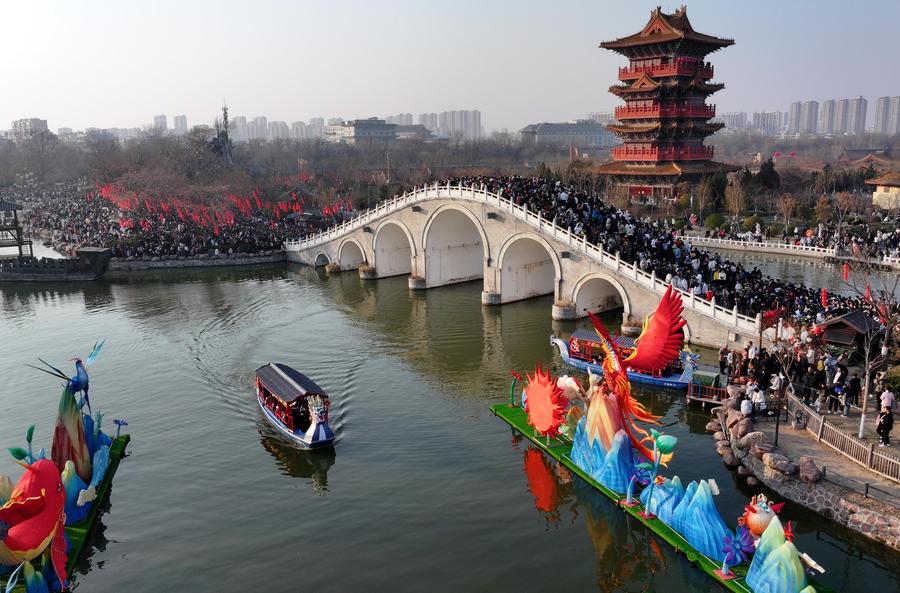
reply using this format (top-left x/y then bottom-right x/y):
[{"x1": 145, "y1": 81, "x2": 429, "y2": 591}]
[{"x1": 786, "y1": 394, "x2": 900, "y2": 482}]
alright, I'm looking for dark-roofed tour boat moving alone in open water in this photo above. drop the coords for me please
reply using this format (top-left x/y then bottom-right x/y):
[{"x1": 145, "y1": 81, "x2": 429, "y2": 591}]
[{"x1": 256, "y1": 362, "x2": 334, "y2": 449}]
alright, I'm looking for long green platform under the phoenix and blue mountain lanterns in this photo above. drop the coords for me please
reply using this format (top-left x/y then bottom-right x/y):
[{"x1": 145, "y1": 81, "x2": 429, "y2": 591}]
[{"x1": 490, "y1": 403, "x2": 836, "y2": 593}]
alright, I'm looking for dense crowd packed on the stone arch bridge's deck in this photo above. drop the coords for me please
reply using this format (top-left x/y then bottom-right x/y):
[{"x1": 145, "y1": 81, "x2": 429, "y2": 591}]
[{"x1": 450, "y1": 176, "x2": 888, "y2": 323}]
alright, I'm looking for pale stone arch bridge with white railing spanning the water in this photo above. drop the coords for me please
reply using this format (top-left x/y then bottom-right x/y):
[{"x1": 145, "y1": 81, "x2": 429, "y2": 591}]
[{"x1": 285, "y1": 185, "x2": 760, "y2": 347}]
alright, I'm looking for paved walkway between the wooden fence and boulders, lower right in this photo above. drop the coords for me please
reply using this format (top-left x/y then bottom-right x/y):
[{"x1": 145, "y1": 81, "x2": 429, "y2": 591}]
[{"x1": 754, "y1": 413, "x2": 900, "y2": 505}]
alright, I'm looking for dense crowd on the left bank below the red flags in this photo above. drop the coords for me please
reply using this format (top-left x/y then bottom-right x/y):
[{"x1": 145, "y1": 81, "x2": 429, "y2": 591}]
[{"x1": 9, "y1": 183, "x2": 314, "y2": 257}]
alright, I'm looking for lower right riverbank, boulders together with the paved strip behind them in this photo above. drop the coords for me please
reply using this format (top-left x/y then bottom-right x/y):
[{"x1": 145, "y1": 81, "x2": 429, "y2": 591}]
[{"x1": 708, "y1": 398, "x2": 900, "y2": 551}]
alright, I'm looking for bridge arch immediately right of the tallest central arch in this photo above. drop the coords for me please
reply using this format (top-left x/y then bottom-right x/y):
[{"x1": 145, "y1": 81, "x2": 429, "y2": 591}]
[{"x1": 497, "y1": 233, "x2": 562, "y2": 303}]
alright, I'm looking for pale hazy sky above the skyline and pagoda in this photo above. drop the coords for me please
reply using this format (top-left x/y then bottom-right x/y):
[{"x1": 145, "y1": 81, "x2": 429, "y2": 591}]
[{"x1": 0, "y1": 0, "x2": 900, "y2": 131}]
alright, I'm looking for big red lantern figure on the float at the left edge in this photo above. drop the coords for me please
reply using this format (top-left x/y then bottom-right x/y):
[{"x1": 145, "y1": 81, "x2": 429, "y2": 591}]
[{"x1": 0, "y1": 459, "x2": 68, "y2": 584}]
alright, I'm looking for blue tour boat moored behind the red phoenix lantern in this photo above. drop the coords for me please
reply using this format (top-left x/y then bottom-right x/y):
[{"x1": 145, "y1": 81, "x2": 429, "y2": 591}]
[{"x1": 550, "y1": 329, "x2": 698, "y2": 389}]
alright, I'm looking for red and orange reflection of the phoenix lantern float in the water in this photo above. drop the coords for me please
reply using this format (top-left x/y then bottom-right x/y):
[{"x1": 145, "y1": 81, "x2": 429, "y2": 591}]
[{"x1": 513, "y1": 446, "x2": 718, "y2": 593}]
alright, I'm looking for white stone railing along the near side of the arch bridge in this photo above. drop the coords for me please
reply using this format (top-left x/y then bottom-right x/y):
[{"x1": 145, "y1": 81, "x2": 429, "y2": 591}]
[{"x1": 284, "y1": 183, "x2": 761, "y2": 335}]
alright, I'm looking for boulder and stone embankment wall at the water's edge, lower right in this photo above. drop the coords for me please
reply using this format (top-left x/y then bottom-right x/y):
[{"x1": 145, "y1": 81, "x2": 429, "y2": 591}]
[{"x1": 706, "y1": 397, "x2": 900, "y2": 550}]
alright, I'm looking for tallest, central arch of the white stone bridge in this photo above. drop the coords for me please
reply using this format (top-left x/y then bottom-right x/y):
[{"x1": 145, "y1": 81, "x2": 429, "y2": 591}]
[{"x1": 422, "y1": 204, "x2": 490, "y2": 288}]
